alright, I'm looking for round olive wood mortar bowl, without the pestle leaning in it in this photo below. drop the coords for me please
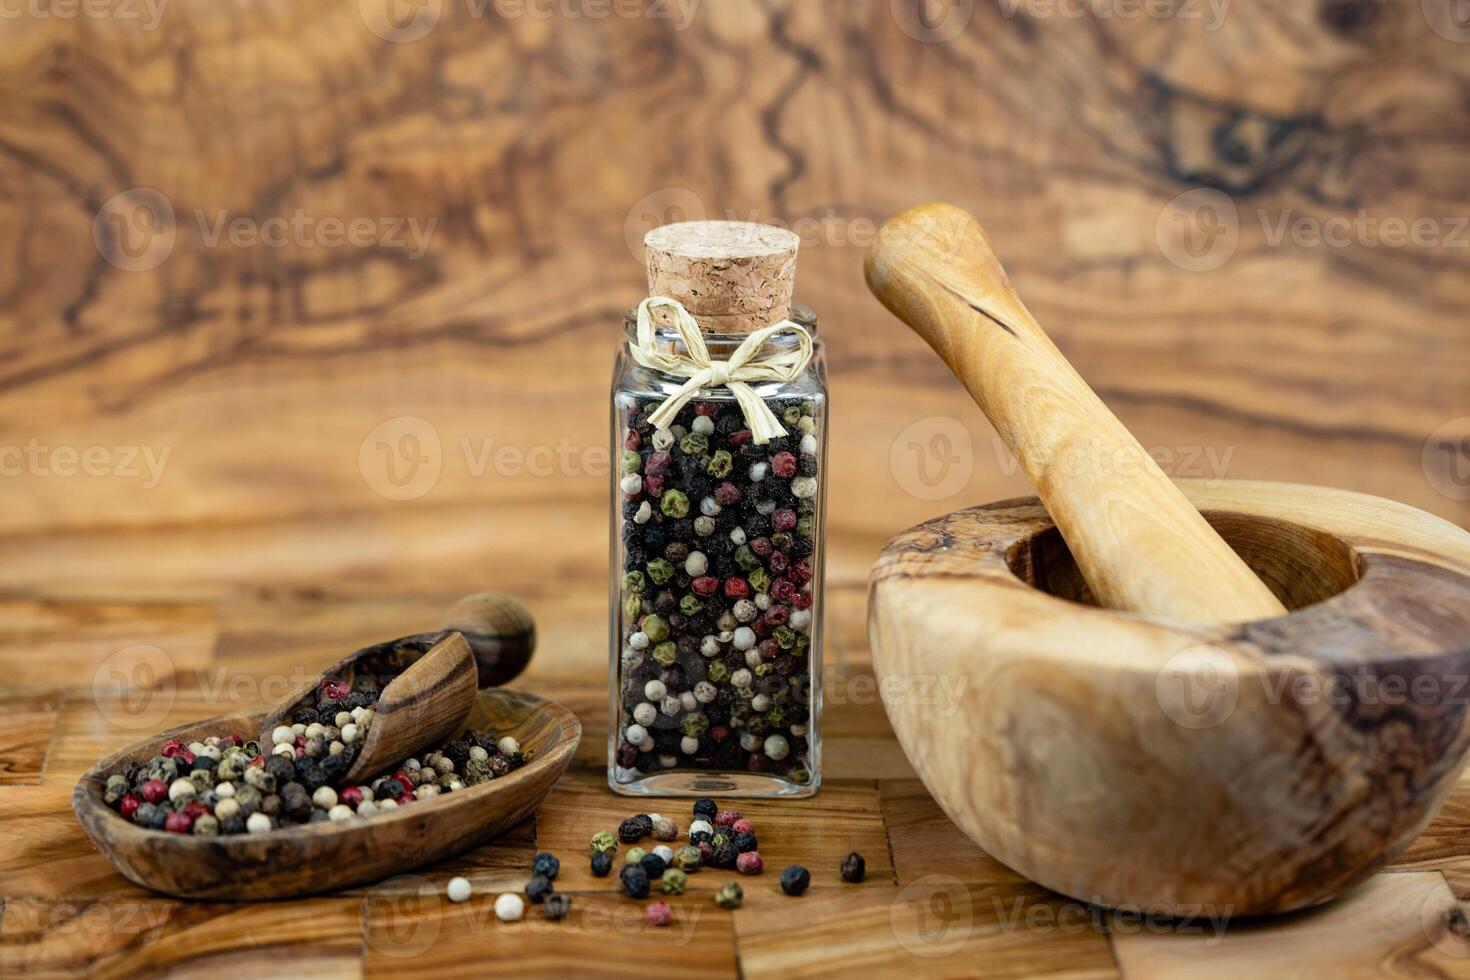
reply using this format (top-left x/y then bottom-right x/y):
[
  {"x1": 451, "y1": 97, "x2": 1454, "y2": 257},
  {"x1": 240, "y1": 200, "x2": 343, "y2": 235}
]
[{"x1": 869, "y1": 480, "x2": 1470, "y2": 915}]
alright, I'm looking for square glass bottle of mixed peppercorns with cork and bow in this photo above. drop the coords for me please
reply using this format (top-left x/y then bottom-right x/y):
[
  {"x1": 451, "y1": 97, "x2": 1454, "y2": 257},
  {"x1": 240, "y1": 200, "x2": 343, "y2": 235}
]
[{"x1": 607, "y1": 222, "x2": 828, "y2": 796}]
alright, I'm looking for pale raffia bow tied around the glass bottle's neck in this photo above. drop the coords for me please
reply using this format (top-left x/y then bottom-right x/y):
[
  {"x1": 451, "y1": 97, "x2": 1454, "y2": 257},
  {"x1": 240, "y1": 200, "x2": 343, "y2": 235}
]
[{"x1": 628, "y1": 295, "x2": 811, "y2": 445}]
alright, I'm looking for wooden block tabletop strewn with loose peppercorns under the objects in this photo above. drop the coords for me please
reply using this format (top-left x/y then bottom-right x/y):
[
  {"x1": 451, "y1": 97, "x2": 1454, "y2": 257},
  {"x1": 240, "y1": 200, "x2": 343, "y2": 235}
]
[{"x1": 0, "y1": 543, "x2": 1470, "y2": 977}]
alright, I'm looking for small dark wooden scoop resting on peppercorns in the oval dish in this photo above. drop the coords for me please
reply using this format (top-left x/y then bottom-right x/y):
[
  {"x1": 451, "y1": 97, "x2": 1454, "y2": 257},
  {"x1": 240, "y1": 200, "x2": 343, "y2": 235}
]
[{"x1": 260, "y1": 592, "x2": 535, "y2": 783}]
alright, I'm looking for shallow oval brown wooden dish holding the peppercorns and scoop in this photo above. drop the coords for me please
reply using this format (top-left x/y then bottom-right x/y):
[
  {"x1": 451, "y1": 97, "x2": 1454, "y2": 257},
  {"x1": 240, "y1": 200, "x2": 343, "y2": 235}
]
[{"x1": 72, "y1": 689, "x2": 582, "y2": 901}]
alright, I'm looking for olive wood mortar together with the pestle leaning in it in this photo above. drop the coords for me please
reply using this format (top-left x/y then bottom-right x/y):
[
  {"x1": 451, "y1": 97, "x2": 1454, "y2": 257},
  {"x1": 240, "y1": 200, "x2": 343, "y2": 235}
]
[{"x1": 867, "y1": 204, "x2": 1470, "y2": 915}]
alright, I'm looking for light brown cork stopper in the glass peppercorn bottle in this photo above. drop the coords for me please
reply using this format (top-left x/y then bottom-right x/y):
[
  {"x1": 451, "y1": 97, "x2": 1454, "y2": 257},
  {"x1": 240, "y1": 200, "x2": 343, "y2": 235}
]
[{"x1": 644, "y1": 222, "x2": 801, "y2": 334}]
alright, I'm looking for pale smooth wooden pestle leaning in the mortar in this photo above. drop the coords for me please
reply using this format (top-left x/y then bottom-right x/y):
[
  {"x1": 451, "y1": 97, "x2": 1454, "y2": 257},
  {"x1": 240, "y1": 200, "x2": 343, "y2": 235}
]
[{"x1": 866, "y1": 204, "x2": 1286, "y2": 623}]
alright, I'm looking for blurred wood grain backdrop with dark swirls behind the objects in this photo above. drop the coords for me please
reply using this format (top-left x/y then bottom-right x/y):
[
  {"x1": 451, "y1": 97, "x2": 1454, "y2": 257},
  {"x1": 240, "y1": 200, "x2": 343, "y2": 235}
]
[{"x1": 0, "y1": 0, "x2": 1470, "y2": 608}]
